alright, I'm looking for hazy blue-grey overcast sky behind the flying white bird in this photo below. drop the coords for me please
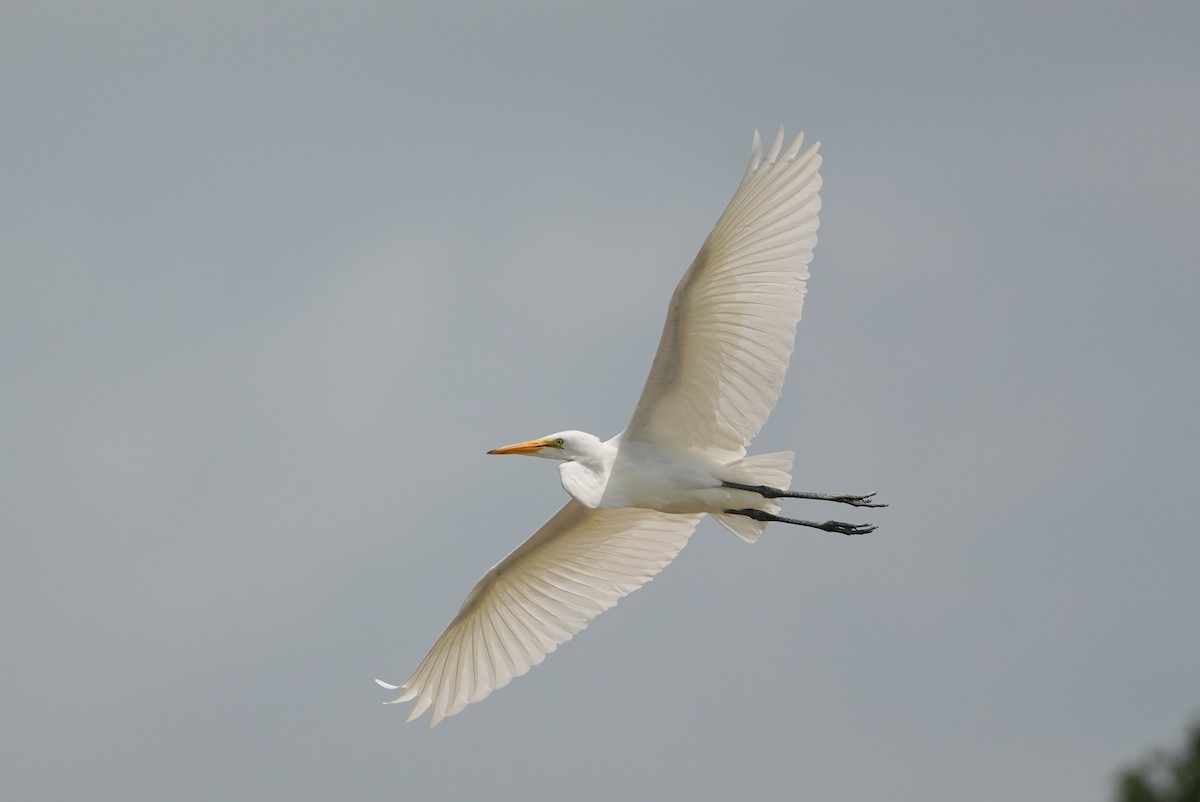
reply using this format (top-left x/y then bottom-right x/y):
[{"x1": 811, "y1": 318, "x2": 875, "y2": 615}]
[{"x1": 0, "y1": 0, "x2": 1200, "y2": 802}]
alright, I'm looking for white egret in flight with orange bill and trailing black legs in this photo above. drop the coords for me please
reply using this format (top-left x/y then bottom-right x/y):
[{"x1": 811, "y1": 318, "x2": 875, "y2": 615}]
[{"x1": 376, "y1": 128, "x2": 884, "y2": 726}]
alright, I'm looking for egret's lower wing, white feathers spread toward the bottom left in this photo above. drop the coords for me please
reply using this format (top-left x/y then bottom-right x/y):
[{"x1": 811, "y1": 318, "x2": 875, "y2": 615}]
[{"x1": 376, "y1": 498, "x2": 702, "y2": 726}]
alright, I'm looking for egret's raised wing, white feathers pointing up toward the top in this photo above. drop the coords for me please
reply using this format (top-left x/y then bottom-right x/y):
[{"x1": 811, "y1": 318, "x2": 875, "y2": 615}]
[{"x1": 625, "y1": 128, "x2": 821, "y2": 462}]
